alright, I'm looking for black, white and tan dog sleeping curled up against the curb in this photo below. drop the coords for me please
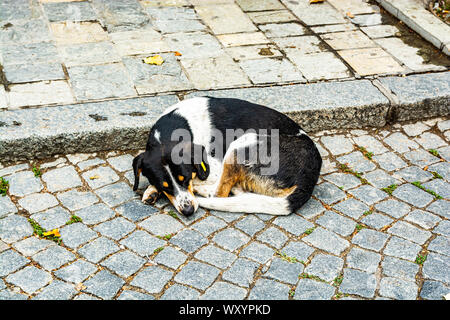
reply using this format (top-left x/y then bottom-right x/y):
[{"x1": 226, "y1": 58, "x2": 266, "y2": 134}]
[{"x1": 133, "y1": 97, "x2": 322, "y2": 216}]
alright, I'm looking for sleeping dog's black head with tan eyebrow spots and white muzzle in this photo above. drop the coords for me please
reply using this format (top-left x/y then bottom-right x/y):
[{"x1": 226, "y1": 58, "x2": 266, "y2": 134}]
[{"x1": 133, "y1": 142, "x2": 209, "y2": 216}]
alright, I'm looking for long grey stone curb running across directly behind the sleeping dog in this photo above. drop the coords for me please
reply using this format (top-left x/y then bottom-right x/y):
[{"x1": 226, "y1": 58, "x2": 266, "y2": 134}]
[{"x1": 0, "y1": 72, "x2": 450, "y2": 162}]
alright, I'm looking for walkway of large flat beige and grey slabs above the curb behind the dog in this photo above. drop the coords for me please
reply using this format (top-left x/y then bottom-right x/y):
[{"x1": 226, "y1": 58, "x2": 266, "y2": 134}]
[{"x1": 0, "y1": 0, "x2": 450, "y2": 110}]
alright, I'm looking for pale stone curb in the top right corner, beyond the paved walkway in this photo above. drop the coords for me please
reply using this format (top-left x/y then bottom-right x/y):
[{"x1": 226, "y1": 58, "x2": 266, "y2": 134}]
[{"x1": 376, "y1": 0, "x2": 450, "y2": 56}]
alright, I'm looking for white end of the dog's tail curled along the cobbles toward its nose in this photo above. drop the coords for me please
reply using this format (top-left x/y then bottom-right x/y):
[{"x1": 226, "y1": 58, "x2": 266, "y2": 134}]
[{"x1": 197, "y1": 193, "x2": 291, "y2": 216}]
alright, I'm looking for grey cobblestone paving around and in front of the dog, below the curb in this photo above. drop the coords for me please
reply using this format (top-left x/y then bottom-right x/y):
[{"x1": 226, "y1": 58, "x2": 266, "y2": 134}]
[{"x1": 0, "y1": 119, "x2": 450, "y2": 299}]
